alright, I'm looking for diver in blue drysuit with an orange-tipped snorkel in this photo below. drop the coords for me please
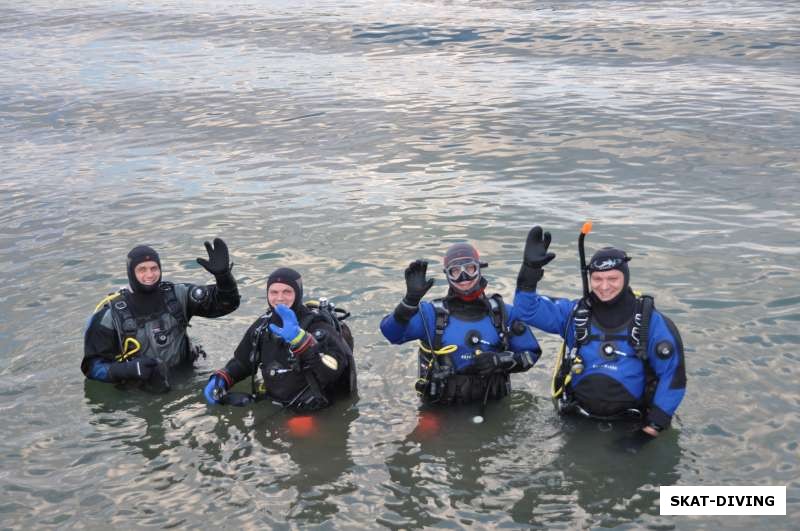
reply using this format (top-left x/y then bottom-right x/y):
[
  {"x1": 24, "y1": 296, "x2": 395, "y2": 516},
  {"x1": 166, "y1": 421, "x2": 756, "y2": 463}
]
[{"x1": 514, "y1": 222, "x2": 686, "y2": 437}]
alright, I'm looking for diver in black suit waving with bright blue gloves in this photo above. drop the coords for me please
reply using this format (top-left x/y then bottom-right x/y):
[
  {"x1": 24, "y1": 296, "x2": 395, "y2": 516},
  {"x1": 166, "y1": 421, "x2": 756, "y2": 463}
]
[{"x1": 203, "y1": 267, "x2": 356, "y2": 411}]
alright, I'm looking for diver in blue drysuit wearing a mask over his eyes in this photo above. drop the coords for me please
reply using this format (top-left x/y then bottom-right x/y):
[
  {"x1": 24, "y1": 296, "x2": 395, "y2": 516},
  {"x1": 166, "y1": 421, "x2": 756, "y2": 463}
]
[{"x1": 380, "y1": 243, "x2": 541, "y2": 406}]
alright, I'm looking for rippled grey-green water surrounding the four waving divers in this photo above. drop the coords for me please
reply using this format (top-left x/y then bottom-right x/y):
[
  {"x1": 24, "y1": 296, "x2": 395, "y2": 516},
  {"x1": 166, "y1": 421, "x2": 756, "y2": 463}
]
[{"x1": 0, "y1": 0, "x2": 800, "y2": 529}]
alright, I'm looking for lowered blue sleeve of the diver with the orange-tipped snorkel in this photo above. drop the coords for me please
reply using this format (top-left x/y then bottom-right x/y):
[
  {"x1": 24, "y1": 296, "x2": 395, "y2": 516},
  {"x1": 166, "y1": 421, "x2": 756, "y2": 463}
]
[{"x1": 647, "y1": 310, "x2": 686, "y2": 428}]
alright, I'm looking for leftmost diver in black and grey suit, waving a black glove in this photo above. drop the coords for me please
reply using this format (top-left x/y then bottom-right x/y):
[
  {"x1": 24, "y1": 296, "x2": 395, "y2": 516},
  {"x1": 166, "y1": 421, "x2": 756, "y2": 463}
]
[{"x1": 81, "y1": 238, "x2": 244, "y2": 391}]
